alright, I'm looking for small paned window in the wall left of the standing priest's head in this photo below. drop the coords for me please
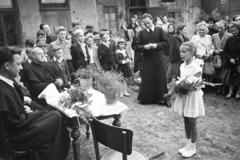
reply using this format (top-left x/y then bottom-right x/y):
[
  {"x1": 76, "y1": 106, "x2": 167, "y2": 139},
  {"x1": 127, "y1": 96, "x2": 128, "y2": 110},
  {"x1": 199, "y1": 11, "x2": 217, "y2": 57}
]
[{"x1": 104, "y1": 6, "x2": 118, "y2": 32}]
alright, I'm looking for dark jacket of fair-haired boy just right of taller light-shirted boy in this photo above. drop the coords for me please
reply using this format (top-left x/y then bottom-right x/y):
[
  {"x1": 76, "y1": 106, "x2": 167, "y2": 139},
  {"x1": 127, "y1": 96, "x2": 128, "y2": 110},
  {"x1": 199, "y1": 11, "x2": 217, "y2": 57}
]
[{"x1": 71, "y1": 42, "x2": 90, "y2": 71}]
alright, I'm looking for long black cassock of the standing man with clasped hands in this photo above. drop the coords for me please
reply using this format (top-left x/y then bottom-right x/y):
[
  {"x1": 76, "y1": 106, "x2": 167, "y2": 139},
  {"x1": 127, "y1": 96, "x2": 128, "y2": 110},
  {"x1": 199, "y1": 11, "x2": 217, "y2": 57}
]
[{"x1": 137, "y1": 27, "x2": 168, "y2": 102}]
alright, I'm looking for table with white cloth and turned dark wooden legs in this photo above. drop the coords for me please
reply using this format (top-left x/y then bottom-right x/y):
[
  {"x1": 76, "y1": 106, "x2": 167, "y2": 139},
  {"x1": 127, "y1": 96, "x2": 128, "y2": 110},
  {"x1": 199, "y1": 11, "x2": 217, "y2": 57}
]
[{"x1": 39, "y1": 84, "x2": 128, "y2": 160}]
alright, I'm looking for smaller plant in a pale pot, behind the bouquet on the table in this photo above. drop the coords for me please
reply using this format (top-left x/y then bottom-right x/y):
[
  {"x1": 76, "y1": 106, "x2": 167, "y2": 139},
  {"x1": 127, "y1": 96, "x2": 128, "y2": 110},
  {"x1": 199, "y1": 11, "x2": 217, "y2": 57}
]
[{"x1": 74, "y1": 67, "x2": 93, "y2": 90}]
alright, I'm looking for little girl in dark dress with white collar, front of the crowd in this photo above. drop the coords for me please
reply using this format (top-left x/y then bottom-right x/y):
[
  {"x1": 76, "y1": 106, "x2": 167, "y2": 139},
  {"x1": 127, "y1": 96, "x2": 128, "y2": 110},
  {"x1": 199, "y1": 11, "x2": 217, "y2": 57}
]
[{"x1": 115, "y1": 40, "x2": 132, "y2": 97}]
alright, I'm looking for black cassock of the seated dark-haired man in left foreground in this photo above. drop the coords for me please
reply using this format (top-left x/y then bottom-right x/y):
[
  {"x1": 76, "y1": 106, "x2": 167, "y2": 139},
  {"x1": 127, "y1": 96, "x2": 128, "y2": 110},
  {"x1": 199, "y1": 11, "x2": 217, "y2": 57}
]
[{"x1": 0, "y1": 80, "x2": 70, "y2": 160}]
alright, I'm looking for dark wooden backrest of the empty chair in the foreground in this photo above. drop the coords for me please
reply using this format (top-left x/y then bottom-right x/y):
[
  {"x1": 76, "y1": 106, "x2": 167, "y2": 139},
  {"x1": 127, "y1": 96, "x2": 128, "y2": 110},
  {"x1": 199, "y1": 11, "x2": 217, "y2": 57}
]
[{"x1": 90, "y1": 118, "x2": 133, "y2": 157}]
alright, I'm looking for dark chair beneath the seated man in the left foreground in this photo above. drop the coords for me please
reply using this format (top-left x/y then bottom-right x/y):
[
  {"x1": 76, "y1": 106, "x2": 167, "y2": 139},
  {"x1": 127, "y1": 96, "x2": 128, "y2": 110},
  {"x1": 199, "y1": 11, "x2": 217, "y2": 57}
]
[{"x1": 0, "y1": 112, "x2": 26, "y2": 160}]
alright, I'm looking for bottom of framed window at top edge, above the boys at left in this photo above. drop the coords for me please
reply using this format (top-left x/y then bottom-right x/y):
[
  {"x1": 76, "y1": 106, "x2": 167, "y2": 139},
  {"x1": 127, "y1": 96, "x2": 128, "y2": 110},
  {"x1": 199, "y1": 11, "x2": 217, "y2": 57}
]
[{"x1": 39, "y1": 0, "x2": 69, "y2": 10}]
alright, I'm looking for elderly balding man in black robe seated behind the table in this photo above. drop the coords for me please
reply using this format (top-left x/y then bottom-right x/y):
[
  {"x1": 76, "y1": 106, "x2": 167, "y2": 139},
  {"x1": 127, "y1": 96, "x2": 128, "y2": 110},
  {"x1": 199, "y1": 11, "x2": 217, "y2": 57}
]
[{"x1": 26, "y1": 47, "x2": 63, "y2": 106}]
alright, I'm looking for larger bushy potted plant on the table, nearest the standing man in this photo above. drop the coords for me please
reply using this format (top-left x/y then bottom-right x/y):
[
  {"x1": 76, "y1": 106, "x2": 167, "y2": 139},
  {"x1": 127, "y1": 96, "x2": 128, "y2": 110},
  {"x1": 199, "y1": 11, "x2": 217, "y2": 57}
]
[{"x1": 95, "y1": 71, "x2": 122, "y2": 104}]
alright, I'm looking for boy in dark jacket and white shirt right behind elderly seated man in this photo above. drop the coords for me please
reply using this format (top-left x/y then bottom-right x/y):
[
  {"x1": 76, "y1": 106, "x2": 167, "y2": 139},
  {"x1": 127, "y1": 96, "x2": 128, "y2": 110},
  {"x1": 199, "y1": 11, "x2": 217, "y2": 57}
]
[{"x1": 52, "y1": 47, "x2": 71, "y2": 85}]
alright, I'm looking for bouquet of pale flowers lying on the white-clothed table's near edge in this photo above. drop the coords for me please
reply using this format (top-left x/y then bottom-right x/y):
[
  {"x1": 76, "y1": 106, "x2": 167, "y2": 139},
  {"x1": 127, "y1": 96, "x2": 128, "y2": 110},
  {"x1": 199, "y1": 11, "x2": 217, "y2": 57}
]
[{"x1": 59, "y1": 86, "x2": 92, "y2": 123}]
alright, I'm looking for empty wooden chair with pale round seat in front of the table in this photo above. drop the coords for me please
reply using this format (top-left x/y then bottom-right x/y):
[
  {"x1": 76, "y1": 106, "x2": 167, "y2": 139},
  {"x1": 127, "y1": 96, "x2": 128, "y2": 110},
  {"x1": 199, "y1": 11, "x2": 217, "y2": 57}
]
[{"x1": 90, "y1": 118, "x2": 148, "y2": 160}]
